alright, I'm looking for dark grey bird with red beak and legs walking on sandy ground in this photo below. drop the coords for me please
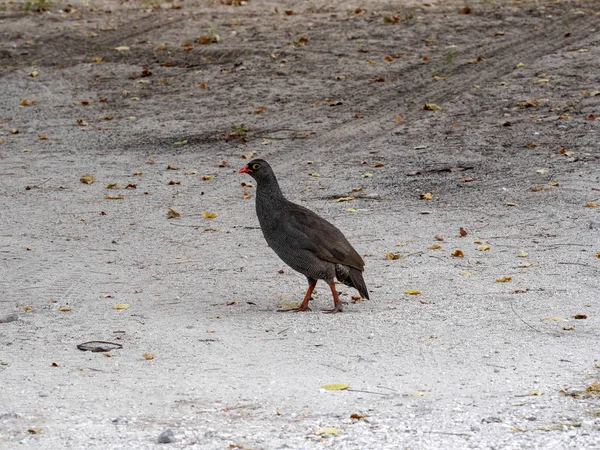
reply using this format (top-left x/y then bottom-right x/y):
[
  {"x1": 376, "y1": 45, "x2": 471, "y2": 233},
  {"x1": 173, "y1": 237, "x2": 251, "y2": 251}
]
[{"x1": 238, "y1": 159, "x2": 369, "y2": 313}]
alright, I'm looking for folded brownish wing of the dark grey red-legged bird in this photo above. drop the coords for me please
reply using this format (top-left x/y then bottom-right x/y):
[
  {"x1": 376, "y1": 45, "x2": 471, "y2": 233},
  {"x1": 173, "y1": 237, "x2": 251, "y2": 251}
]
[{"x1": 288, "y1": 202, "x2": 365, "y2": 271}]
